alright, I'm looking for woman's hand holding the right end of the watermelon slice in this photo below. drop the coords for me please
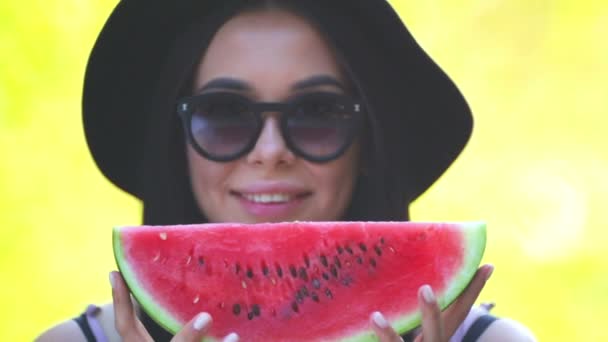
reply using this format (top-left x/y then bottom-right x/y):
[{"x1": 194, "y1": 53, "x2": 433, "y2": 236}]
[{"x1": 370, "y1": 265, "x2": 494, "y2": 342}]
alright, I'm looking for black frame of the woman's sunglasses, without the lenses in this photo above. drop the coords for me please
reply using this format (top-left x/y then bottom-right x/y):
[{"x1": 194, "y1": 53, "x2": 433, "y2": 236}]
[{"x1": 177, "y1": 91, "x2": 364, "y2": 163}]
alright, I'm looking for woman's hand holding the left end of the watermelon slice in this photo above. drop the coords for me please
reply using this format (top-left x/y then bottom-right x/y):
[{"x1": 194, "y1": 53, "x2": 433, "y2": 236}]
[{"x1": 110, "y1": 272, "x2": 239, "y2": 342}]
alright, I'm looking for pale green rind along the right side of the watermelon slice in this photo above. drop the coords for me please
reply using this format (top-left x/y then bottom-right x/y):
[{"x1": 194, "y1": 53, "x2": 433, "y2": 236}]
[{"x1": 341, "y1": 222, "x2": 486, "y2": 342}]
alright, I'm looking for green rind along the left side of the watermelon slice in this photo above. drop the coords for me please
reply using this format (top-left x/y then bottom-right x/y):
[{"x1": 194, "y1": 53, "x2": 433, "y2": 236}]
[{"x1": 112, "y1": 227, "x2": 183, "y2": 336}]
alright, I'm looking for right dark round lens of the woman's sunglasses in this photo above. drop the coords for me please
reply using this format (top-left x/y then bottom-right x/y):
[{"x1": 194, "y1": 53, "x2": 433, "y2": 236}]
[{"x1": 287, "y1": 94, "x2": 356, "y2": 159}]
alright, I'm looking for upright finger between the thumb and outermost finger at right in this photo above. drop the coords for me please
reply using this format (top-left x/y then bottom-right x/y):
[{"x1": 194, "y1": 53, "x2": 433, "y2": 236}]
[{"x1": 418, "y1": 285, "x2": 443, "y2": 342}]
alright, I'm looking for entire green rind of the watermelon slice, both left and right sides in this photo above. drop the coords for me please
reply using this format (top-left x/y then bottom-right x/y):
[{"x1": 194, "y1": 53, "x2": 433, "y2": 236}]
[{"x1": 113, "y1": 222, "x2": 486, "y2": 342}]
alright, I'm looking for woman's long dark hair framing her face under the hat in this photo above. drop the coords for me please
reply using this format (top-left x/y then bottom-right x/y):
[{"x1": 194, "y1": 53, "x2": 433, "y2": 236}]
[{"x1": 140, "y1": 0, "x2": 408, "y2": 230}]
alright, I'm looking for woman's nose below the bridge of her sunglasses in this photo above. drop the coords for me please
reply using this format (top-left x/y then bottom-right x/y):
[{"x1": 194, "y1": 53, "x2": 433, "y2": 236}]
[{"x1": 247, "y1": 115, "x2": 295, "y2": 167}]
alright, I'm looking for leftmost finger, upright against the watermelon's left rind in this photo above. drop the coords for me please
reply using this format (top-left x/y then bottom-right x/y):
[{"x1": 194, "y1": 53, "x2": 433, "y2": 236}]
[{"x1": 110, "y1": 272, "x2": 152, "y2": 341}]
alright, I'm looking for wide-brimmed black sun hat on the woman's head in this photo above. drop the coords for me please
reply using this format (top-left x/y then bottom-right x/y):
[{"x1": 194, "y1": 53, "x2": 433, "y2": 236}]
[{"x1": 82, "y1": 0, "x2": 473, "y2": 202}]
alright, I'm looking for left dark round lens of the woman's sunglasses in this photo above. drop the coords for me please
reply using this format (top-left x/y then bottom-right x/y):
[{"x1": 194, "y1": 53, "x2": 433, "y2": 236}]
[{"x1": 190, "y1": 96, "x2": 258, "y2": 158}]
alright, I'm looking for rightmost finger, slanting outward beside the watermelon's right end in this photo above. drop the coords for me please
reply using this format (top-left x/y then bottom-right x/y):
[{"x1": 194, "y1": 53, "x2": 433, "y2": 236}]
[{"x1": 443, "y1": 265, "x2": 494, "y2": 336}]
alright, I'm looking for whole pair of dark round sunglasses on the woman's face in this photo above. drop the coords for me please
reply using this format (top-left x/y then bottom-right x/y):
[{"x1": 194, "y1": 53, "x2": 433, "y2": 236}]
[{"x1": 178, "y1": 91, "x2": 363, "y2": 163}]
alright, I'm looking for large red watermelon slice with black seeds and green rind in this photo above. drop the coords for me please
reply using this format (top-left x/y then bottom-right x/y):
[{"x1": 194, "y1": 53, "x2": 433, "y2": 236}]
[{"x1": 113, "y1": 222, "x2": 486, "y2": 341}]
